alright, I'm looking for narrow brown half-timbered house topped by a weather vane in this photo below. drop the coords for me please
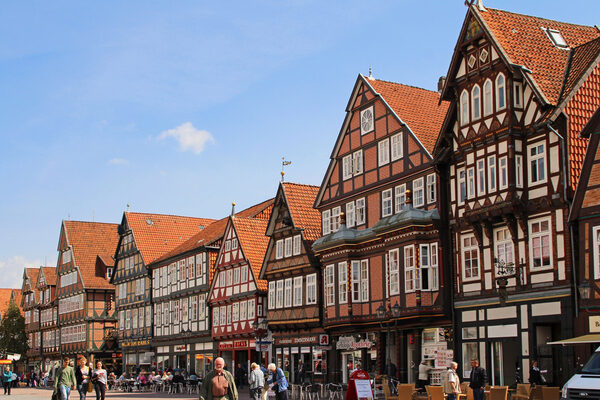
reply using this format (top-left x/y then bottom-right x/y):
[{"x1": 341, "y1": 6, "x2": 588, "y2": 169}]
[{"x1": 259, "y1": 182, "x2": 328, "y2": 384}]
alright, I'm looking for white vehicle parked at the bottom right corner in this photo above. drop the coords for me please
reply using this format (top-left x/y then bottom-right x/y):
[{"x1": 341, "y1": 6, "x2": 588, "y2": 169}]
[{"x1": 562, "y1": 347, "x2": 600, "y2": 400}]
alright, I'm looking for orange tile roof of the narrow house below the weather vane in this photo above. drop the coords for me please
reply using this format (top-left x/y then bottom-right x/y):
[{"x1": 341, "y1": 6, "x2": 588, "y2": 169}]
[{"x1": 283, "y1": 182, "x2": 321, "y2": 242}]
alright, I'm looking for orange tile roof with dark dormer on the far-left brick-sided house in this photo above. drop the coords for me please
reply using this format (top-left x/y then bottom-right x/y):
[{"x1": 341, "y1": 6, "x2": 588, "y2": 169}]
[{"x1": 63, "y1": 221, "x2": 119, "y2": 289}]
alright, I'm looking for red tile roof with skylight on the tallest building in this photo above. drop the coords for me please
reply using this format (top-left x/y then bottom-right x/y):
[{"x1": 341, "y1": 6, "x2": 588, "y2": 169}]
[{"x1": 478, "y1": 6, "x2": 600, "y2": 105}]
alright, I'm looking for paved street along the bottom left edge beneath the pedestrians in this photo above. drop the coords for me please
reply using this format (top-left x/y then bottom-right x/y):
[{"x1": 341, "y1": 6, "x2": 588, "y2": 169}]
[{"x1": 0, "y1": 388, "x2": 250, "y2": 400}]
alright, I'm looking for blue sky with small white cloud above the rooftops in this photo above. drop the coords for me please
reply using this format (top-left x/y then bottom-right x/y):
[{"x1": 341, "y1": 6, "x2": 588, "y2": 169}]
[{"x1": 0, "y1": 0, "x2": 600, "y2": 288}]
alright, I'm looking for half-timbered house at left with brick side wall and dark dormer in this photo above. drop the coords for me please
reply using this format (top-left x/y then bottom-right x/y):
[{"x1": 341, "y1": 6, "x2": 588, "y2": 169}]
[{"x1": 56, "y1": 221, "x2": 118, "y2": 369}]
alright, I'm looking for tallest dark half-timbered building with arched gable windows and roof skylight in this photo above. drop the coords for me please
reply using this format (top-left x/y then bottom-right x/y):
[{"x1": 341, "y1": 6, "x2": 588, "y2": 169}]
[{"x1": 435, "y1": 2, "x2": 600, "y2": 385}]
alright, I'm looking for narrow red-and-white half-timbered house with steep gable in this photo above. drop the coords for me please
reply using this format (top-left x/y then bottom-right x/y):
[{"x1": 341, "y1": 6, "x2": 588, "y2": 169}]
[{"x1": 208, "y1": 214, "x2": 270, "y2": 372}]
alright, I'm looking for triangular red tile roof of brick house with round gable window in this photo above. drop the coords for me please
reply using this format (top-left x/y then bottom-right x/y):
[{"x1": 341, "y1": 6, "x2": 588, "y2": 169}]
[{"x1": 365, "y1": 78, "x2": 450, "y2": 154}]
